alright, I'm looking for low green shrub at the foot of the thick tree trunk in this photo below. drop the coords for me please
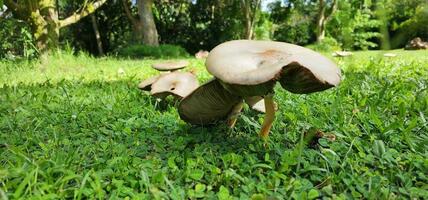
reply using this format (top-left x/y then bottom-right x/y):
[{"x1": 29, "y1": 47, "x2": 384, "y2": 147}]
[{"x1": 117, "y1": 44, "x2": 189, "y2": 58}]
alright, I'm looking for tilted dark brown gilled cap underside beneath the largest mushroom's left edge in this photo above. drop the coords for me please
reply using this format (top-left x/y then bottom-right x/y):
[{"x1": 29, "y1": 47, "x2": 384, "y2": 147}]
[{"x1": 178, "y1": 79, "x2": 242, "y2": 125}]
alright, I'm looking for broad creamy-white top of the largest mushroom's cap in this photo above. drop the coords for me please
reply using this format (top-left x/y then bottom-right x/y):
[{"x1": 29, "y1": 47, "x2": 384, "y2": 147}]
[{"x1": 205, "y1": 40, "x2": 340, "y2": 95}]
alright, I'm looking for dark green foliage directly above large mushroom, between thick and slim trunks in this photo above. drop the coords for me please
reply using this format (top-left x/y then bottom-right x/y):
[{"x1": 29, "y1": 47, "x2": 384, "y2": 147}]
[{"x1": 154, "y1": 0, "x2": 244, "y2": 53}]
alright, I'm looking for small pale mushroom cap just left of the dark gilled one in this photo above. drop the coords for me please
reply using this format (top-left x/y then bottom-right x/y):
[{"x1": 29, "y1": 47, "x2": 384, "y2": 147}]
[{"x1": 150, "y1": 72, "x2": 199, "y2": 97}]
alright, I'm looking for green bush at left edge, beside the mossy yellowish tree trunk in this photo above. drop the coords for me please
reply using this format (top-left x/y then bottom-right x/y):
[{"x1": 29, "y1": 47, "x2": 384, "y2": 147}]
[{"x1": 0, "y1": 18, "x2": 37, "y2": 59}]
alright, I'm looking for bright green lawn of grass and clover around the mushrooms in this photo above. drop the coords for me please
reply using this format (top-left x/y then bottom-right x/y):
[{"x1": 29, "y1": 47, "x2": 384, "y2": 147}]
[{"x1": 0, "y1": 50, "x2": 428, "y2": 199}]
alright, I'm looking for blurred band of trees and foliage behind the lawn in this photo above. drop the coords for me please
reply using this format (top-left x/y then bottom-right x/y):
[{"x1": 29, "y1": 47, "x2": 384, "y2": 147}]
[{"x1": 0, "y1": 0, "x2": 428, "y2": 59}]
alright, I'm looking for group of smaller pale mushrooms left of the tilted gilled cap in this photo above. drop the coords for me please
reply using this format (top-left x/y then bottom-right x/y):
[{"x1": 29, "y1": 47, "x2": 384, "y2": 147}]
[{"x1": 138, "y1": 61, "x2": 199, "y2": 99}]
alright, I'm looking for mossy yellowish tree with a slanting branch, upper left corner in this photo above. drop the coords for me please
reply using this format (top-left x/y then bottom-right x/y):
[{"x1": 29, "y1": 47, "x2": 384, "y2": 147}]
[{"x1": 4, "y1": 0, "x2": 107, "y2": 53}]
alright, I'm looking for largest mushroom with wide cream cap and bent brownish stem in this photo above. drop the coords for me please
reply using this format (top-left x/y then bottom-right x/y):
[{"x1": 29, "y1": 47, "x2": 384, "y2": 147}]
[{"x1": 205, "y1": 40, "x2": 340, "y2": 139}]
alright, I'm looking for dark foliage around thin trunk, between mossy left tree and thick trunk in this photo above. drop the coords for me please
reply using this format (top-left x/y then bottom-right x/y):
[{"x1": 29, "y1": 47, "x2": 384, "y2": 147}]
[{"x1": 59, "y1": 0, "x2": 131, "y2": 55}]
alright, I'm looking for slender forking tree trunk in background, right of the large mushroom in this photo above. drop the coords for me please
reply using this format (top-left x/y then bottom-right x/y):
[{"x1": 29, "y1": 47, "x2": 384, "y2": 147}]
[{"x1": 317, "y1": 0, "x2": 337, "y2": 42}]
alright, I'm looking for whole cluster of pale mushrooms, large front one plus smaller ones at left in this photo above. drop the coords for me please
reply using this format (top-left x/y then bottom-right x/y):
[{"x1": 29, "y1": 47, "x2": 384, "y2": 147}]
[{"x1": 139, "y1": 40, "x2": 341, "y2": 139}]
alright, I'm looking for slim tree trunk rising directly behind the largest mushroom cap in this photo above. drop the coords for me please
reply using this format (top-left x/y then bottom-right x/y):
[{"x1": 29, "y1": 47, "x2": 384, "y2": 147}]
[{"x1": 241, "y1": 0, "x2": 261, "y2": 40}]
